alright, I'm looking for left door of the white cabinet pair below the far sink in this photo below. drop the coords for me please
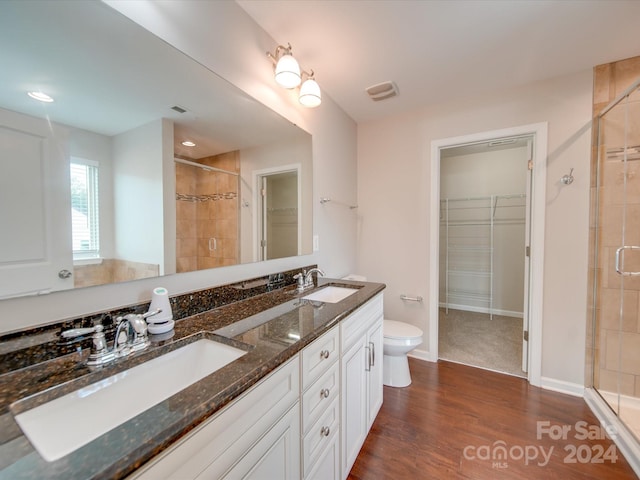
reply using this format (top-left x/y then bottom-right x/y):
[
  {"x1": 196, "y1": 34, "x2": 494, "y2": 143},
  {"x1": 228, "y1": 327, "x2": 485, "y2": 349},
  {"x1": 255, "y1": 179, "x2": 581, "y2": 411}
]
[{"x1": 340, "y1": 338, "x2": 367, "y2": 478}]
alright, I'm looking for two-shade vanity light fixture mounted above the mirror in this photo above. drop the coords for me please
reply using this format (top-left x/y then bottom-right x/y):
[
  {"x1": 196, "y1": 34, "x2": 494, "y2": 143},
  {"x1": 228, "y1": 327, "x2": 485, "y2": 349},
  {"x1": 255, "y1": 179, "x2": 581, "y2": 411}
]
[{"x1": 267, "y1": 43, "x2": 322, "y2": 108}]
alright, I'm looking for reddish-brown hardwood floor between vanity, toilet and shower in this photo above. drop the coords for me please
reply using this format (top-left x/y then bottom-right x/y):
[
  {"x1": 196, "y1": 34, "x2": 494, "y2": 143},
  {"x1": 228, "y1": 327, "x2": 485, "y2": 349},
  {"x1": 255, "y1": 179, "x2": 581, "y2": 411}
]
[{"x1": 349, "y1": 358, "x2": 637, "y2": 480}]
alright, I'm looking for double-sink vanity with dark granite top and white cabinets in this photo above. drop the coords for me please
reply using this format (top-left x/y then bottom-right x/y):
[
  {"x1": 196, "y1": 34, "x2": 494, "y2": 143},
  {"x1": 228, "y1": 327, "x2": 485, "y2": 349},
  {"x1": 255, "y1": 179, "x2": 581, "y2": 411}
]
[{"x1": 0, "y1": 279, "x2": 385, "y2": 480}]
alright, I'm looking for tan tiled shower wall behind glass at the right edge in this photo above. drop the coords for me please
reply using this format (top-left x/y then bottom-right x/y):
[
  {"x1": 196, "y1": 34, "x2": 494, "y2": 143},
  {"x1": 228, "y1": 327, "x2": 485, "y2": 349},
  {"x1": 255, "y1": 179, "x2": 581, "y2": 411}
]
[{"x1": 585, "y1": 57, "x2": 640, "y2": 396}]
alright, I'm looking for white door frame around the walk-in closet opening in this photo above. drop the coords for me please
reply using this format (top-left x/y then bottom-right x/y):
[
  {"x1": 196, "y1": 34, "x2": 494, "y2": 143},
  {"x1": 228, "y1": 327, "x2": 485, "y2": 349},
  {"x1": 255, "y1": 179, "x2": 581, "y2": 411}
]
[{"x1": 429, "y1": 122, "x2": 548, "y2": 386}]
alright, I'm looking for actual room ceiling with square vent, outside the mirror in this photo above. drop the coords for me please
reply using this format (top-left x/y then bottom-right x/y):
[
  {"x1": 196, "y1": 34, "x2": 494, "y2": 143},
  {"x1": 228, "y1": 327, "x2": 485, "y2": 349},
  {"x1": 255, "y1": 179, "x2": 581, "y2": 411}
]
[{"x1": 236, "y1": 0, "x2": 640, "y2": 122}]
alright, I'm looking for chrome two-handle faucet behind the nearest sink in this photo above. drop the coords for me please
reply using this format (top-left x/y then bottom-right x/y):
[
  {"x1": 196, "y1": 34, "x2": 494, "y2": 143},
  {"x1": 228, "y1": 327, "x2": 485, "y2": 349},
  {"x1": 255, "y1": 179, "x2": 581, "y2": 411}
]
[{"x1": 60, "y1": 308, "x2": 162, "y2": 366}]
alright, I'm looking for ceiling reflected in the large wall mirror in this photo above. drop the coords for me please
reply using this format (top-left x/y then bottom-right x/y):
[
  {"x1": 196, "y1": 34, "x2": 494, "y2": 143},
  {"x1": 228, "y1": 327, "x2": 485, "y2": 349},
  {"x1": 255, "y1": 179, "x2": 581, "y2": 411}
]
[{"x1": 0, "y1": 0, "x2": 306, "y2": 159}]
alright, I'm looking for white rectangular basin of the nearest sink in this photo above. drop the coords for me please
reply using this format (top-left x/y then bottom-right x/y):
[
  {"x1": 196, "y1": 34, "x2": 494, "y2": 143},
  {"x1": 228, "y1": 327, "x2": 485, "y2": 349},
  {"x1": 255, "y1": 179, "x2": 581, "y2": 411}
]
[{"x1": 15, "y1": 339, "x2": 247, "y2": 462}]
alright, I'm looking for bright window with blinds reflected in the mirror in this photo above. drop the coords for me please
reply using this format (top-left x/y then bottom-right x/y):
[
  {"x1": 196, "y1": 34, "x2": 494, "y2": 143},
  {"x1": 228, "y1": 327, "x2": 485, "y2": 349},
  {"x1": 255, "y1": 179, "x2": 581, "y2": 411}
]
[{"x1": 70, "y1": 158, "x2": 100, "y2": 260}]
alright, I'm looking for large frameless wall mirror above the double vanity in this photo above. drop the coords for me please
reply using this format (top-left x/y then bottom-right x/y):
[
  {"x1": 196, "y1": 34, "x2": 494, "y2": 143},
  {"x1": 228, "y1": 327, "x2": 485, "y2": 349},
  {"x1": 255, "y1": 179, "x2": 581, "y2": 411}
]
[{"x1": 0, "y1": 0, "x2": 313, "y2": 299}]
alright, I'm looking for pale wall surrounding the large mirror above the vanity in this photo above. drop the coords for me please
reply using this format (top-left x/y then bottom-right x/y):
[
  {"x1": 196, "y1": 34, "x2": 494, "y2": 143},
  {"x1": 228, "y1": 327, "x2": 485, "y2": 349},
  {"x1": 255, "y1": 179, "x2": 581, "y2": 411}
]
[{"x1": 0, "y1": 0, "x2": 357, "y2": 333}]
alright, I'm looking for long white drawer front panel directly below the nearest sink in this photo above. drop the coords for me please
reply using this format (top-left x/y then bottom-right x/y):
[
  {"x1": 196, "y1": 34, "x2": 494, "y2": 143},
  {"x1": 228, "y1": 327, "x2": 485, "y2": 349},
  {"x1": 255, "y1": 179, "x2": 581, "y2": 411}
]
[{"x1": 129, "y1": 356, "x2": 300, "y2": 480}]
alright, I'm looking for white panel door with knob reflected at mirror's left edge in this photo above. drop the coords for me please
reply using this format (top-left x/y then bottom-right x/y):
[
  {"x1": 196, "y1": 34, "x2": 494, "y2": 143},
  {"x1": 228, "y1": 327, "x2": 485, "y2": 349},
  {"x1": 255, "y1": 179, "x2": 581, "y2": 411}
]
[{"x1": 0, "y1": 109, "x2": 73, "y2": 299}]
